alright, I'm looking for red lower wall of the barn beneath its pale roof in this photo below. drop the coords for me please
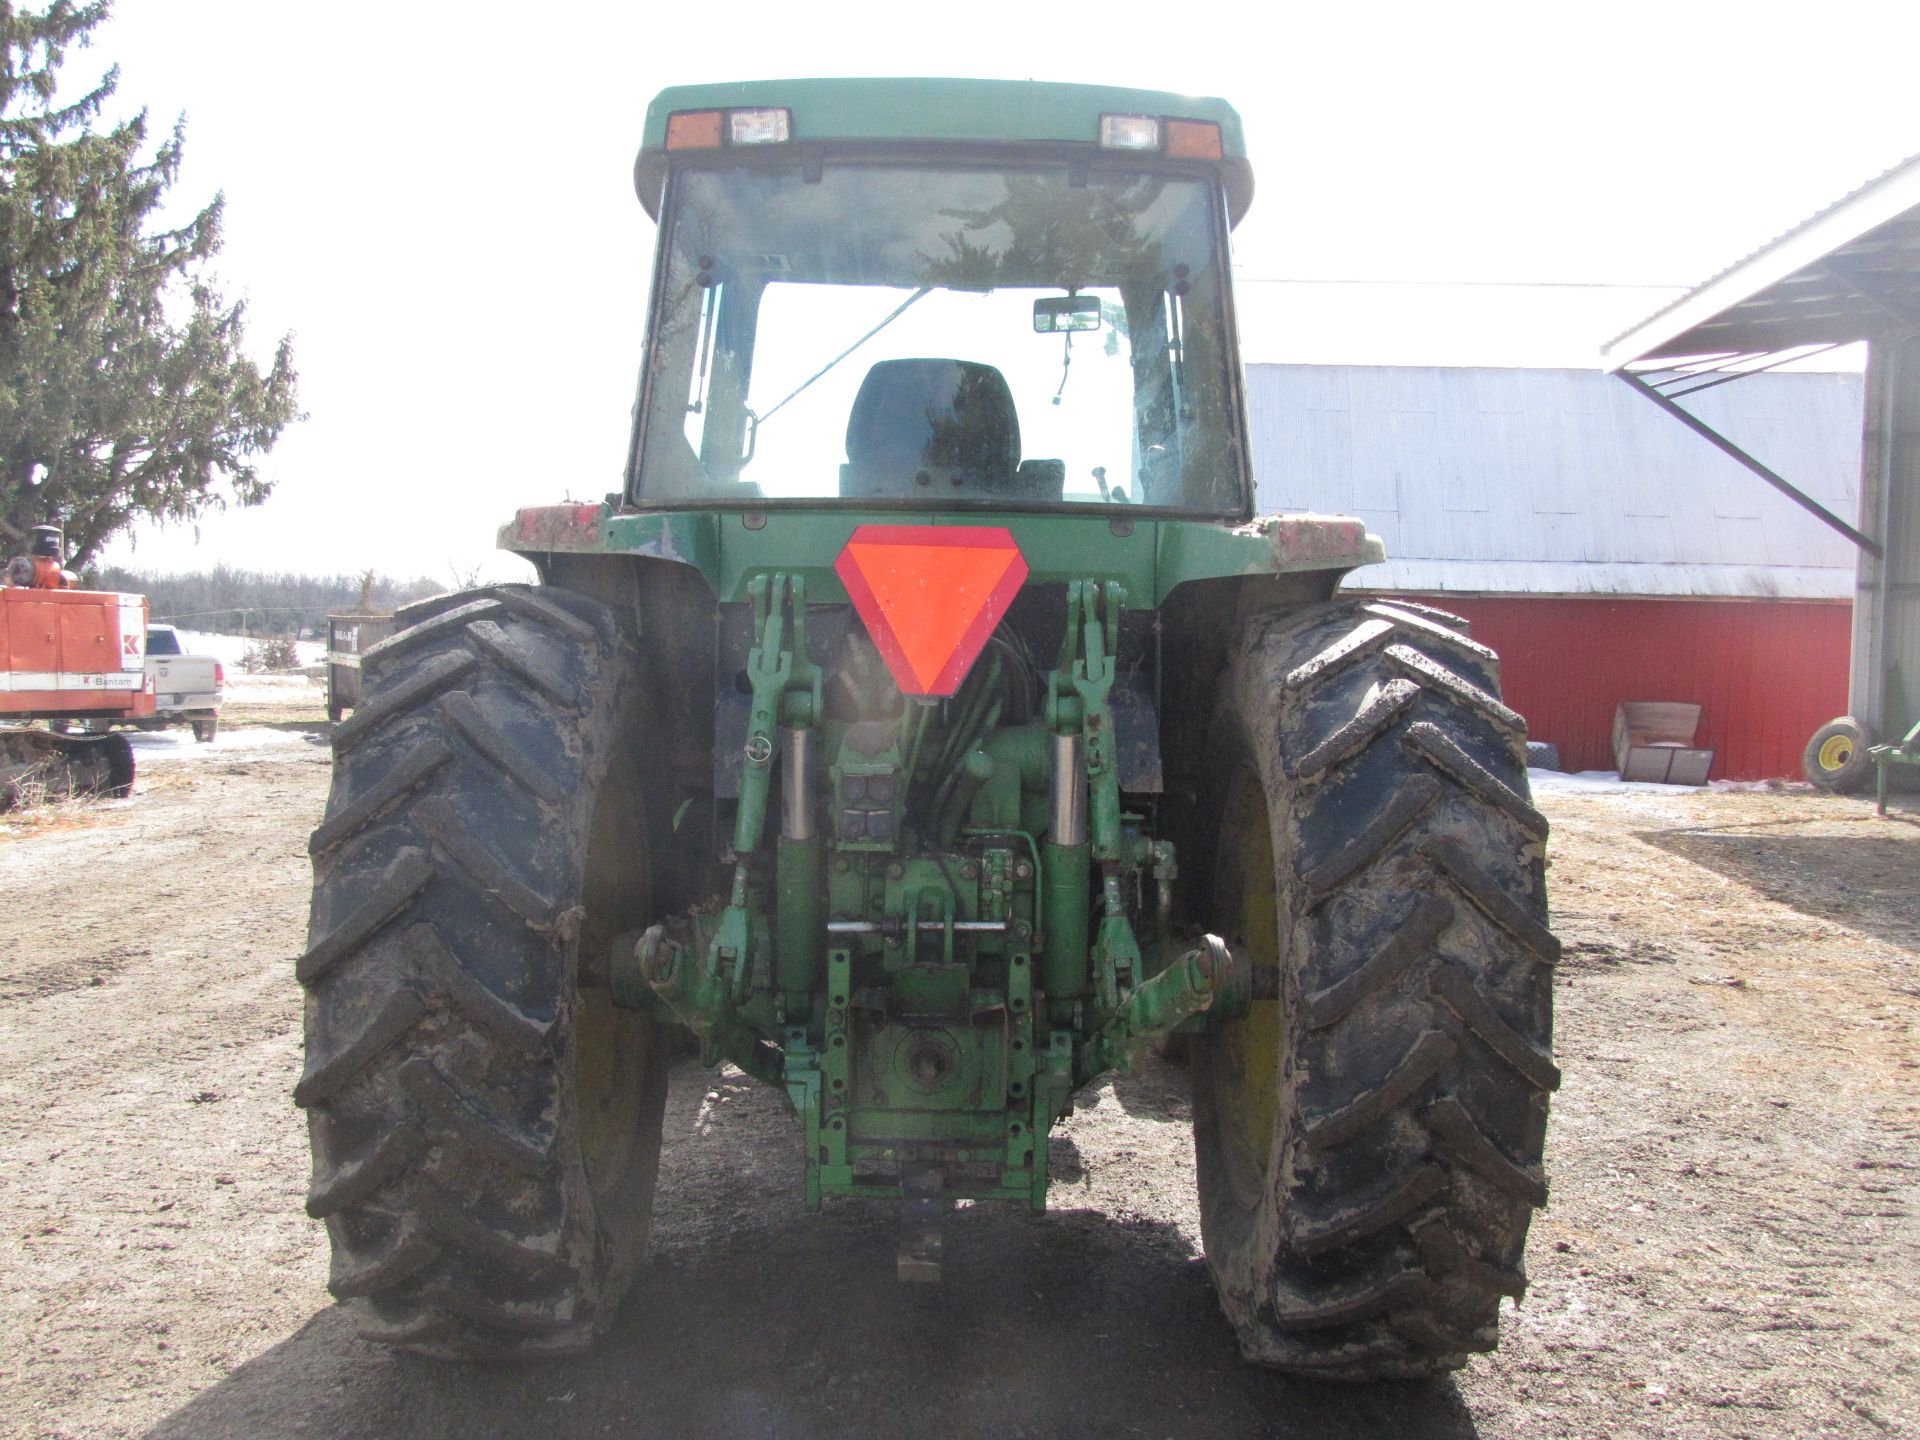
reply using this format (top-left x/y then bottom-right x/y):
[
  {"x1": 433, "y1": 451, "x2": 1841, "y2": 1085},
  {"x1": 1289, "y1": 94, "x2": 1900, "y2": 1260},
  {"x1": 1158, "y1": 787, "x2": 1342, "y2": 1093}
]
[{"x1": 1407, "y1": 595, "x2": 1853, "y2": 780}]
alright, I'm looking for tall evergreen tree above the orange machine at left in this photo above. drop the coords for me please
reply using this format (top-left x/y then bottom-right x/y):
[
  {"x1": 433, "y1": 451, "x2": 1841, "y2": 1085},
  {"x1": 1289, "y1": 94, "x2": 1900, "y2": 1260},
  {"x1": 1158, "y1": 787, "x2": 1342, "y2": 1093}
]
[{"x1": 0, "y1": 0, "x2": 300, "y2": 566}]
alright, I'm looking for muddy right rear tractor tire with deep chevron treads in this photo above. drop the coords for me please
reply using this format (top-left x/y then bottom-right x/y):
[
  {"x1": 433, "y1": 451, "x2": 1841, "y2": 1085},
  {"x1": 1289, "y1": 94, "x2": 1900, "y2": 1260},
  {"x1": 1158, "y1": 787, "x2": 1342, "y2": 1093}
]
[{"x1": 1192, "y1": 603, "x2": 1559, "y2": 1380}]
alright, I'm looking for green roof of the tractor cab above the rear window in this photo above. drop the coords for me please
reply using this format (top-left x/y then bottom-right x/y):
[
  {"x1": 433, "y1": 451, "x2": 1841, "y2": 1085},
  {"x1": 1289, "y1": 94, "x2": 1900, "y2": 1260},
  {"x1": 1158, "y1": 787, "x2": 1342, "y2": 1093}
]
[{"x1": 634, "y1": 79, "x2": 1254, "y2": 225}]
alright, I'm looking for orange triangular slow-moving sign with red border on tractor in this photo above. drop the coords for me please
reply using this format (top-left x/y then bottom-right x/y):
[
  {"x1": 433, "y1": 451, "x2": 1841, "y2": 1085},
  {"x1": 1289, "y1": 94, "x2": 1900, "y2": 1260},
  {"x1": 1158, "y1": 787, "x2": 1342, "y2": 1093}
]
[{"x1": 833, "y1": 524, "x2": 1027, "y2": 695}]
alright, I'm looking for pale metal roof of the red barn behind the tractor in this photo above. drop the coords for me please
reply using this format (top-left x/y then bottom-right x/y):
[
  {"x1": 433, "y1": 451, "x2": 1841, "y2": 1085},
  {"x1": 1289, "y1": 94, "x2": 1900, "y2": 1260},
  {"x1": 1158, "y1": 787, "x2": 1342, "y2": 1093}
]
[{"x1": 1248, "y1": 365, "x2": 1862, "y2": 599}]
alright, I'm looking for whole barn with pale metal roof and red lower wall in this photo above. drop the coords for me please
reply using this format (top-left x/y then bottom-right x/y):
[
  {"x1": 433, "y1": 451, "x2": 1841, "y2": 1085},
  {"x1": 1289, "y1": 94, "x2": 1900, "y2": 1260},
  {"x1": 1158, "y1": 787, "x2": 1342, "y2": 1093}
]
[{"x1": 1248, "y1": 365, "x2": 1862, "y2": 778}]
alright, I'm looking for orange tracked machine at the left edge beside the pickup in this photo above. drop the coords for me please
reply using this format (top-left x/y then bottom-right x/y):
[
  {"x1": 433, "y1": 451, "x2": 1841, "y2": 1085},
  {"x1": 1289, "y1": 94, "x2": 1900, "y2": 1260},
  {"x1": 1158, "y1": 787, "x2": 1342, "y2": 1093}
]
[{"x1": 0, "y1": 526, "x2": 154, "y2": 810}]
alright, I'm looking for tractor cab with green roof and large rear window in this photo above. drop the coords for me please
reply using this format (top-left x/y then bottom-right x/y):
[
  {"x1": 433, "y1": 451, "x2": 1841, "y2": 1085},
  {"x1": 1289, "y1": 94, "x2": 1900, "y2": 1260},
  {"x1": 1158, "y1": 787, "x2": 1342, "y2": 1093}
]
[{"x1": 628, "y1": 81, "x2": 1252, "y2": 518}]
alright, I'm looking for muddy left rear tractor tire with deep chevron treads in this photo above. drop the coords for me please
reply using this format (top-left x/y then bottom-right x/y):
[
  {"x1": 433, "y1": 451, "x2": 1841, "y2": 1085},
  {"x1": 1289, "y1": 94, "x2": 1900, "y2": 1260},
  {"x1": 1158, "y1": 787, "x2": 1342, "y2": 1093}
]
[{"x1": 294, "y1": 586, "x2": 666, "y2": 1359}]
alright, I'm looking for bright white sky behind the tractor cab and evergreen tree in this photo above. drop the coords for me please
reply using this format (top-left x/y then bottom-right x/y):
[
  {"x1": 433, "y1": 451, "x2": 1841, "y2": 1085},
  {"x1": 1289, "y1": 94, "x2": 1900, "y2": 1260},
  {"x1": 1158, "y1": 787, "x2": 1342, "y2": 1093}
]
[{"x1": 82, "y1": 0, "x2": 1920, "y2": 580}]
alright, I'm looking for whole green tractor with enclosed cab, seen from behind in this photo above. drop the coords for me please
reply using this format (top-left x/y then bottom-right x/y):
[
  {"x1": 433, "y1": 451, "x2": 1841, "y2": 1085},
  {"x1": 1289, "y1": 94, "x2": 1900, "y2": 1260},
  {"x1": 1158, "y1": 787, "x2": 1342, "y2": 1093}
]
[{"x1": 296, "y1": 81, "x2": 1559, "y2": 1379}]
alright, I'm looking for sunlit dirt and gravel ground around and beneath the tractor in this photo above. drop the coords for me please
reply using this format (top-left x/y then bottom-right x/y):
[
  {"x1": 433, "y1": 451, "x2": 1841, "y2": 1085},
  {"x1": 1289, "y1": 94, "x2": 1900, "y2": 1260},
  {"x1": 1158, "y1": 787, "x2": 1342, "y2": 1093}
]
[{"x1": 0, "y1": 707, "x2": 1920, "y2": 1440}]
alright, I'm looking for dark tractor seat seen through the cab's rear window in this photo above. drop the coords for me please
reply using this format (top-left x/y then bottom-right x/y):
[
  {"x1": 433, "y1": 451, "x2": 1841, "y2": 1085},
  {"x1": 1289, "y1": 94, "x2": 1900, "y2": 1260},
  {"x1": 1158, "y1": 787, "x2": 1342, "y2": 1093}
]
[{"x1": 841, "y1": 359, "x2": 1066, "y2": 499}]
